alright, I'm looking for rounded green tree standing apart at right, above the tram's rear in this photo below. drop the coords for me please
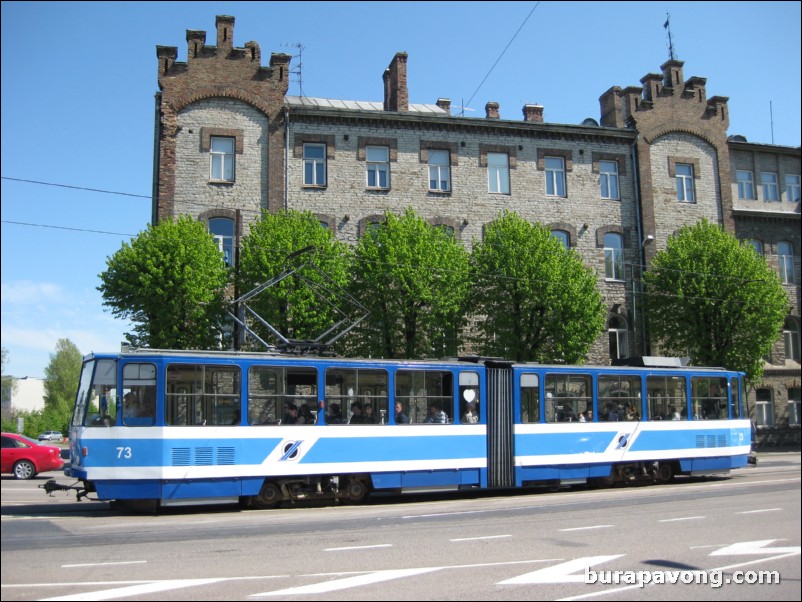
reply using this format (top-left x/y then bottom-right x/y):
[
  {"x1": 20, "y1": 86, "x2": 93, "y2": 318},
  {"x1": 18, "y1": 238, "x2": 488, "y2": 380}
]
[{"x1": 643, "y1": 220, "x2": 788, "y2": 382}]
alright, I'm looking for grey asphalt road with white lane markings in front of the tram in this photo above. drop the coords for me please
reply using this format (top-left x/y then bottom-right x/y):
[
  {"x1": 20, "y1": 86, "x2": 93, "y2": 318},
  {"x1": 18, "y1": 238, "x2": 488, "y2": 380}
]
[{"x1": 1, "y1": 453, "x2": 802, "y2": 601}]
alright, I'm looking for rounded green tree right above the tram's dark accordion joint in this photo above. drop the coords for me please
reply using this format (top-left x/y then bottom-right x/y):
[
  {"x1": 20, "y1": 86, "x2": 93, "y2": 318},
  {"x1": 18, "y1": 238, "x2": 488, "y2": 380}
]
[{"x1": 472, "y1": 211, "x2": 605, "y2": 364}]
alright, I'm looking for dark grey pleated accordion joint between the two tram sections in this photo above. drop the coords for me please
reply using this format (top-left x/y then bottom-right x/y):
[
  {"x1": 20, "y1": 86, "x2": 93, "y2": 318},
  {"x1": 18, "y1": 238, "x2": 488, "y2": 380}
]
[{"x1": 485, "y1": 362, "x2": 515, "y2": 487}]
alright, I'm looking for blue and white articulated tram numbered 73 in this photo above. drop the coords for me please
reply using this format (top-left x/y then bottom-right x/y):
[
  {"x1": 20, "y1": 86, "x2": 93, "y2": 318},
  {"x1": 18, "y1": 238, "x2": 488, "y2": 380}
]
[{"x1": 56, "y1": 349, "x2": 751, "y2": 508}]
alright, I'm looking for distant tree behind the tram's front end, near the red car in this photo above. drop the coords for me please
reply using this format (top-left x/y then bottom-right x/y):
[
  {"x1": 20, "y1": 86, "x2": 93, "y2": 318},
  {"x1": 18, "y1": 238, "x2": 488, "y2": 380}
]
[{"x1": 43, "y1": 339, "x2": 83, "y2": 433}]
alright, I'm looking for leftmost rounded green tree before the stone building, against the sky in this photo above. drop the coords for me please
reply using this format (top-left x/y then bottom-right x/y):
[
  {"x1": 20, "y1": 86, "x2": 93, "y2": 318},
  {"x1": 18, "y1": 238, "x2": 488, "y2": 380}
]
[{"x1": 98, "y1": 216, "x2": 228, "y2": 349}]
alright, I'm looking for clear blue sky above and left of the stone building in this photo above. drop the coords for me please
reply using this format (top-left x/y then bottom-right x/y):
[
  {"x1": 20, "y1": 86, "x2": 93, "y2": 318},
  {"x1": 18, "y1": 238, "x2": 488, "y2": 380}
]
[{"x1": 1, "y1": 2, "x2": 802, "y2": 377}]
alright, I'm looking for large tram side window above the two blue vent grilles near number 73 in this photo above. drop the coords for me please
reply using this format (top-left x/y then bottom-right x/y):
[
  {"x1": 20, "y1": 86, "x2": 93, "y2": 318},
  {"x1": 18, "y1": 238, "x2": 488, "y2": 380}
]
[{"x1": 165, "y1": 364, "x2": 242, "y2": 426}]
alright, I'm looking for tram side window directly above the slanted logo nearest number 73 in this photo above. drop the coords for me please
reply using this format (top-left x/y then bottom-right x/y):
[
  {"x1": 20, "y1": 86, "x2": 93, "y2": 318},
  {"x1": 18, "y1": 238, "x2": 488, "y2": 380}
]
[{"x1": 248, "y1": 366, "x2": 317, "y2": 424}]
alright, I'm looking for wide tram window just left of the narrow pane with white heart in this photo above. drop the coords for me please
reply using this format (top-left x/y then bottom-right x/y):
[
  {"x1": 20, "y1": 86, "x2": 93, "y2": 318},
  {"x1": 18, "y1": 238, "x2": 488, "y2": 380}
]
[{"x1": 395, "y1": 370, "x2": 454, "y2": 424}]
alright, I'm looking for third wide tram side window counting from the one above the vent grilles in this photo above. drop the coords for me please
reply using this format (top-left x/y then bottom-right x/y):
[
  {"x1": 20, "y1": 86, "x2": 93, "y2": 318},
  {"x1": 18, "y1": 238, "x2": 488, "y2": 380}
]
[{"x1": 326, "y1": 368, "x2": 389, "y2": 424}]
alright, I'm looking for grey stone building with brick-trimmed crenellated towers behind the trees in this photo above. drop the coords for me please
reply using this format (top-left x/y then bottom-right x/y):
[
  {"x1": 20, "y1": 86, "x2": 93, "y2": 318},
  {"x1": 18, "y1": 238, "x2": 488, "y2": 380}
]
[{"x1": 152, "y1": 16, "x2": 801, "y2": 440}]
